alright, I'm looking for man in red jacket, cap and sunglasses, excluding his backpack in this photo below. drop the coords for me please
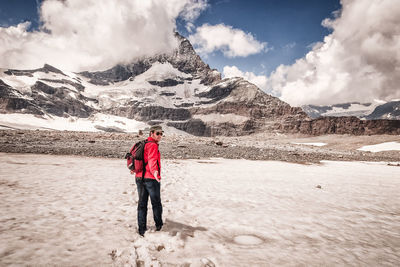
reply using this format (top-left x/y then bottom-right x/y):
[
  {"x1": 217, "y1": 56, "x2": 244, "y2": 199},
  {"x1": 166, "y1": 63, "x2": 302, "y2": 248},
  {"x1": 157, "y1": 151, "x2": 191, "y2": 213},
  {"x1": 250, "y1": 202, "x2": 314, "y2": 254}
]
[{"x1": 135, "y1": 125, "x2": 164, "y2": 236}]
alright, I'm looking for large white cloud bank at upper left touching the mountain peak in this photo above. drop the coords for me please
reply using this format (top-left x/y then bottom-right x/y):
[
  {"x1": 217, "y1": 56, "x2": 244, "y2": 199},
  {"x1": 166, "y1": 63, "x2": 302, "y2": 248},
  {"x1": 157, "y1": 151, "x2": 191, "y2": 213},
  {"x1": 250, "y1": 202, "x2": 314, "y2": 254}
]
[{"x1": 0, "y1": 0, "x2": 206, "y2": 71}]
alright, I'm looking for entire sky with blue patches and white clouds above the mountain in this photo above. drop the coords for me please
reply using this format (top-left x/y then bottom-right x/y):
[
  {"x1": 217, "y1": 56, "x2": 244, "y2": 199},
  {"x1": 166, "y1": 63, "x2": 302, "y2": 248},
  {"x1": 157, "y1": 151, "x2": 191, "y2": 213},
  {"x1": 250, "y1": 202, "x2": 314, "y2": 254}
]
[{"x1": 0, "y1": 0, "x2": 400, "y2": 105}]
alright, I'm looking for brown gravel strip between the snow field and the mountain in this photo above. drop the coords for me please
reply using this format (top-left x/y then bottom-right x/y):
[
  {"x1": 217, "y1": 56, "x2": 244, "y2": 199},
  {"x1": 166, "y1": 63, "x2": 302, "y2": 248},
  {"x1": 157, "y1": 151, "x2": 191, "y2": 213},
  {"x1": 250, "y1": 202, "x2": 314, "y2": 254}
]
[{"x1": 0, "y1": 130, "x2": 400, "y2": 163}]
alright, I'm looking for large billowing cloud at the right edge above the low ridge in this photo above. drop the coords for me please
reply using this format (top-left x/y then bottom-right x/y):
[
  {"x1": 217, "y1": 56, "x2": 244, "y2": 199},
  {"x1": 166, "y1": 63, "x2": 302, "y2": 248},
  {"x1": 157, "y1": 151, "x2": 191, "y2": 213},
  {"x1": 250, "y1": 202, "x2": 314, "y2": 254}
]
[{"x1": 267, "y1": 0, "x2": 400, "y2": 105}]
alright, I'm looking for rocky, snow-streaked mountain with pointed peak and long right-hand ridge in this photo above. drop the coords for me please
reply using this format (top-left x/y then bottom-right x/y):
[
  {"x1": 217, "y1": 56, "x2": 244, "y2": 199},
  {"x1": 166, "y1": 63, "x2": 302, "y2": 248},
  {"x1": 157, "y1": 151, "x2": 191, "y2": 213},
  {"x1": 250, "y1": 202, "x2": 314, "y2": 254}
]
[{"x1": 0, "y1": 34, "x2": 400, "y2": 136}]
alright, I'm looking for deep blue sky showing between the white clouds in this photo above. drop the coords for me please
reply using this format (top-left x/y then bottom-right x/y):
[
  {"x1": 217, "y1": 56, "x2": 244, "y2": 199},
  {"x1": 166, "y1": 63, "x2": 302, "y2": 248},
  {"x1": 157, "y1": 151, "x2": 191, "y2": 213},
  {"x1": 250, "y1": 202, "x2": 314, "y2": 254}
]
[{"x1": 0, "y1": 0, "x2": 341, "y2": 75}]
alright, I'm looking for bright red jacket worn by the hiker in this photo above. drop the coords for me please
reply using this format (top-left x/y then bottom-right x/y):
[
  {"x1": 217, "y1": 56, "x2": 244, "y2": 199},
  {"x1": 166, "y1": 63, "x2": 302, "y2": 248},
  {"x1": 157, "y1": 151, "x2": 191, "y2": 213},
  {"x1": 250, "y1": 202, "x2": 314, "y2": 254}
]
[{"x1": 136, "y1": 137, "x2": 161, "y2": 180}]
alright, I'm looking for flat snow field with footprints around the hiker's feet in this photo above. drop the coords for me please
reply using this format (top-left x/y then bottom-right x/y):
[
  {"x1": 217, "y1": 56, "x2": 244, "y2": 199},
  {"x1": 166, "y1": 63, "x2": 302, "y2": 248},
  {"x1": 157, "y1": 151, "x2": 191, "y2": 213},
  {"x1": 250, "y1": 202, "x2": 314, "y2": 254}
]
[{"x1": 0, "y1": 154, "x2": 400, "y2": 266}]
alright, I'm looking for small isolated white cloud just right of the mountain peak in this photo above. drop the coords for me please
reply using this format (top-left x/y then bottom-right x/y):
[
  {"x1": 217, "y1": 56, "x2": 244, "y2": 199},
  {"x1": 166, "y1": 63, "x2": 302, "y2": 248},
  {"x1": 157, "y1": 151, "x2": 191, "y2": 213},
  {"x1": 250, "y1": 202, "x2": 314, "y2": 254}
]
[{"x1": 189, "y1": 24, "x2": 269, "y2": 57}]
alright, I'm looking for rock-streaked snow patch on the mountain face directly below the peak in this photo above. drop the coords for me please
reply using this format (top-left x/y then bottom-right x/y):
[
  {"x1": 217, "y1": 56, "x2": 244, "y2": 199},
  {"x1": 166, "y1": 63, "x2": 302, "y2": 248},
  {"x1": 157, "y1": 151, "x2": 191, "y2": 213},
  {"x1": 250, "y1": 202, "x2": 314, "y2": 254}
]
[{"x1": 82, "y1": 62, "x2": 214, "y2": 109}]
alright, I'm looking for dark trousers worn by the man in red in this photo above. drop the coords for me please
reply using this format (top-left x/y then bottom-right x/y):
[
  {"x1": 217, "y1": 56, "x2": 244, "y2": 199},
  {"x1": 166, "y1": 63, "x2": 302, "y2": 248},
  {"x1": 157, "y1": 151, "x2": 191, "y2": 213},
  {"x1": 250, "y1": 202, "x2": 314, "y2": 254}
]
[{"x1": 136, "y1": 178, "x2": 163, "y2": 232}]
